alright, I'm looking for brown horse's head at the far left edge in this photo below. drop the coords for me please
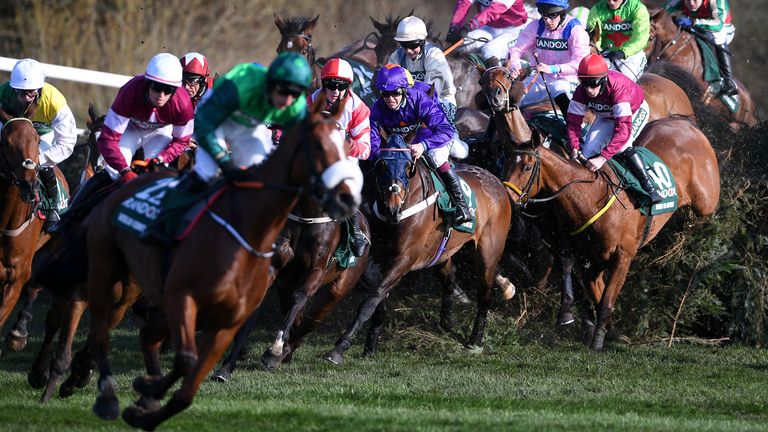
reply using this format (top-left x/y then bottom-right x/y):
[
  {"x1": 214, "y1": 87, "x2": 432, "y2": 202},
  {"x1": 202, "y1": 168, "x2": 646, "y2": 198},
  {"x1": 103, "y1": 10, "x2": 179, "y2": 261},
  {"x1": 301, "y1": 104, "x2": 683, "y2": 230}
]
[{"x1": 0, "y1": 110, "x2": 40, "y2": 203}]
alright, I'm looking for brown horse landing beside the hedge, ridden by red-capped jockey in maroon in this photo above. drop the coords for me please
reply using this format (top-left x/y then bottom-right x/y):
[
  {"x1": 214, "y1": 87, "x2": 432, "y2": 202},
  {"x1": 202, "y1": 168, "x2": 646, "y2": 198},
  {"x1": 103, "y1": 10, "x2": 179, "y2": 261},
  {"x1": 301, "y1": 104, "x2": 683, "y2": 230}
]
[{"x1": 506, "y1": 113, "x2": 720, "y2": 350}]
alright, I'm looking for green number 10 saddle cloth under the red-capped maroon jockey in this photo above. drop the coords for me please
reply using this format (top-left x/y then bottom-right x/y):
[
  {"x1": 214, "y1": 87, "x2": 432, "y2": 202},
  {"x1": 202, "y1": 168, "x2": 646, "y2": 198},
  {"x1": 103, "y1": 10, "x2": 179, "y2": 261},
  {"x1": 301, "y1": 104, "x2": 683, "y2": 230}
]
[{"x1": 608, "y1": 147, "x2": 677, "y2": 215}]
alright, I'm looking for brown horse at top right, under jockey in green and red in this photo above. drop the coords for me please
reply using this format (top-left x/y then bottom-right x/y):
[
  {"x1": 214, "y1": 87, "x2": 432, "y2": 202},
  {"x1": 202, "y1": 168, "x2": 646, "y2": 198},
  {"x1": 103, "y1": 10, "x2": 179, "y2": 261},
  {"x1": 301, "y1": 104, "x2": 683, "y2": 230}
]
[{"x1": 645, "y1": 8, "x2": 758, "y2": 130}]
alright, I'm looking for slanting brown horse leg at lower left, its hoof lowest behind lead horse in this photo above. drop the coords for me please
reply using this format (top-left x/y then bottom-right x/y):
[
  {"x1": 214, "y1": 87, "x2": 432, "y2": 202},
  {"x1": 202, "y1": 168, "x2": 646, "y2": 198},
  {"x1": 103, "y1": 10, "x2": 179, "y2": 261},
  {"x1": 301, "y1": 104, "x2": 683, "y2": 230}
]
[{"x1": 40, "y1": 298, "x2": 88, "y2": 403}]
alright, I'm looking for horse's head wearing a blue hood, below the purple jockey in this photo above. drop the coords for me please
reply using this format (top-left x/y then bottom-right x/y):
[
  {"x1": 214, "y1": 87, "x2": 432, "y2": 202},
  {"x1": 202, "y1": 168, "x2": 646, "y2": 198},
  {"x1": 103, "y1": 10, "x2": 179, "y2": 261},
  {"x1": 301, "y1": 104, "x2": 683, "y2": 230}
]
[{"x1": 376, "y1": 129, "x2": 416, "y2": 224}]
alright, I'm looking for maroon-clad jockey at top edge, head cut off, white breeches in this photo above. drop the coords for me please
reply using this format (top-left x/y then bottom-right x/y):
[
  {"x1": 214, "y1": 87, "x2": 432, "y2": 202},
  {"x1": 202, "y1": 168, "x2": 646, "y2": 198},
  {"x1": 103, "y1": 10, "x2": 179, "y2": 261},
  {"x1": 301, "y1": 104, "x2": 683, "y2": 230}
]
[{"x1": 445, "y1": 0, "x2": 528, "y2": 66}]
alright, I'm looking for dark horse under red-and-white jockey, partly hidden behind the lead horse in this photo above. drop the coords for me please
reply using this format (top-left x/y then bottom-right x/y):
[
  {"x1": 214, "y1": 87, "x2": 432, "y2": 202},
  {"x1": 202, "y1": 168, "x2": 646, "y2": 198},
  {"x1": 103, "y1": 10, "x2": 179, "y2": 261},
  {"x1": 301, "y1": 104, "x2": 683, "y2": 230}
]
[{"x1": 212, "y1": 202, "x2": 370, "y2": 382}]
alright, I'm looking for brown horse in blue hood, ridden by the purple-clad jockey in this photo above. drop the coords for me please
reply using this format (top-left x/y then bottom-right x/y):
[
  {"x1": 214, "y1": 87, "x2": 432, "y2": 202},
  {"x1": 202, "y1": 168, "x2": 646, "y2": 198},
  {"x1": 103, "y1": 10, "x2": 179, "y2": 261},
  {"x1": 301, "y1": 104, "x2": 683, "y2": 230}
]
[{"x1": 323, "y1": 131, "x2": 514, "y2": 364}]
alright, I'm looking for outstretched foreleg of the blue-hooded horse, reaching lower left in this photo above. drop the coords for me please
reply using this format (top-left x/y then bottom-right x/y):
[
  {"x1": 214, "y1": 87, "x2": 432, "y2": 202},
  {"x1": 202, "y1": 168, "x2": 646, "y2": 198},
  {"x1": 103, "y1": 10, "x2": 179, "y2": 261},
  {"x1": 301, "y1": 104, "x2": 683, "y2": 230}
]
[{"x1": 323, "y1": 259, "x2": 413, "y2": 365}]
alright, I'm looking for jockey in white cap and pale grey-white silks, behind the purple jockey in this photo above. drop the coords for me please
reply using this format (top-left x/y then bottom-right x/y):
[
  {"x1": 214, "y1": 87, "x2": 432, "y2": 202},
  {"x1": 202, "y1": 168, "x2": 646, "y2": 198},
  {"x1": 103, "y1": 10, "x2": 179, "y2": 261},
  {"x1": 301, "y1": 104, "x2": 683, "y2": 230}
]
[{"x1": 389, "y1": 16, "x2": 468, "y2": 159}]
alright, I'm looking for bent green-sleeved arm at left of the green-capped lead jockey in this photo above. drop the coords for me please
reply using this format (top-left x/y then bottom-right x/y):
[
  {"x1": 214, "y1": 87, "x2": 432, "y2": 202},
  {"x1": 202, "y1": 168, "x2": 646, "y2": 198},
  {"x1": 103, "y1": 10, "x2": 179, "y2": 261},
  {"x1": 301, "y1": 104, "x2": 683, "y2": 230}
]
[{"x1": 194, "y1": 79, "x2": 240, "y2": 165}]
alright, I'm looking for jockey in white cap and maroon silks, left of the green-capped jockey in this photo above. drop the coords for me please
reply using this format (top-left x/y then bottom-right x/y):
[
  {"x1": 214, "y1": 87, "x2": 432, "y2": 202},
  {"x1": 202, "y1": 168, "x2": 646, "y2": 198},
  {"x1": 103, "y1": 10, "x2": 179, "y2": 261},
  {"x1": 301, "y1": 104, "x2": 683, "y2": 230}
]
[{"x1": 96, "y1": 53, "x2": 194, "y2": 183}]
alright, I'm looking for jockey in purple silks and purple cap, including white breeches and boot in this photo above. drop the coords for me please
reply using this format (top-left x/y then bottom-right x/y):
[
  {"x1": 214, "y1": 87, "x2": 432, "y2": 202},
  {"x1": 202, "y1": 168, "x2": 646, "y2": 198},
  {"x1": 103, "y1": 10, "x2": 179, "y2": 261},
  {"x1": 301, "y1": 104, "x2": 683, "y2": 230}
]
[{"x1": 371, "y1": 66, "x2": 474, "y2": 224}]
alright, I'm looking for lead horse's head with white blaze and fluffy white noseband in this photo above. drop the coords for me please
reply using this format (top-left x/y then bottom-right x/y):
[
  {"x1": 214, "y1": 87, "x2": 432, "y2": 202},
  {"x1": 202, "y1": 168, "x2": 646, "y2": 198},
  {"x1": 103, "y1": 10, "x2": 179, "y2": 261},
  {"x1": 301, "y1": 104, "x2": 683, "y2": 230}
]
[{"x1": 281, "y1": 92, "x2": 363, "y2": 220}]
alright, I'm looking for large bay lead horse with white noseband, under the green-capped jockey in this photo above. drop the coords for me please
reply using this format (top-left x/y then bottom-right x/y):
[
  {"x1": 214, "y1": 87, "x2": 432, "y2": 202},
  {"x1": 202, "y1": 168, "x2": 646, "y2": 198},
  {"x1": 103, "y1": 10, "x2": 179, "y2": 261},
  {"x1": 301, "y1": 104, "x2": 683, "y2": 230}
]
[{"x1": 73, "y1": 96, "x2": 362, "y2": 430}]
